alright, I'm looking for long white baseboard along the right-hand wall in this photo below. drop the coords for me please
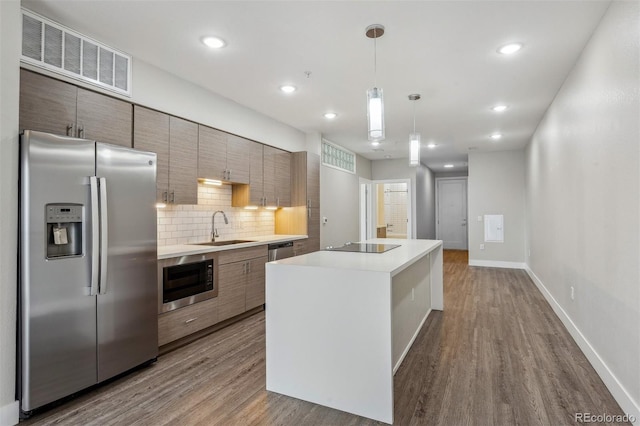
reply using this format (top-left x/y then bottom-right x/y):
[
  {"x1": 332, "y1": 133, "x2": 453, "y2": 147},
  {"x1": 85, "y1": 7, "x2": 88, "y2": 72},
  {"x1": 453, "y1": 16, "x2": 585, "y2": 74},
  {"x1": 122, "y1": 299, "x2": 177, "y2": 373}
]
[{"x1": 524, "y1": 265, "x2": 640, "y2": 425}]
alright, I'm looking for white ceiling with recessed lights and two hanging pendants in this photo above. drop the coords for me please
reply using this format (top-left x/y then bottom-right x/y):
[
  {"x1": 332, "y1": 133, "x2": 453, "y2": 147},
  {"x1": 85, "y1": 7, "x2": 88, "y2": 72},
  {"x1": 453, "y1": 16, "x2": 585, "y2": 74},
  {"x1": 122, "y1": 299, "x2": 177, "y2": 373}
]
[{"x1": 22, "y1": 0, "x2": 610, "y2": 172}]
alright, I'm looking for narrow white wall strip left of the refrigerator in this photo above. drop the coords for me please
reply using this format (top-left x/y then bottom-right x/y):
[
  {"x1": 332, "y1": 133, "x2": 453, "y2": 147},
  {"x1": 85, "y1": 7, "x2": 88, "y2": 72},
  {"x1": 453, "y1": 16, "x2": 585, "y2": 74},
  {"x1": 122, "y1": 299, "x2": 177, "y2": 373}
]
[{"x1": 0, "y1": 0, "x2": 21, "y2": 425}]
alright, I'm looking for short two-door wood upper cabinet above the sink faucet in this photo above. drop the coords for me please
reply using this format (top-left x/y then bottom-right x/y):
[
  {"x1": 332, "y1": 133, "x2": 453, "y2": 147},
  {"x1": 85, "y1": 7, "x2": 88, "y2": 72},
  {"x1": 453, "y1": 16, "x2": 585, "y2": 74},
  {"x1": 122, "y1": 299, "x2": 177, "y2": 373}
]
[{"x1": 198, "y1": 125, "x2": 252, "y2": 184}]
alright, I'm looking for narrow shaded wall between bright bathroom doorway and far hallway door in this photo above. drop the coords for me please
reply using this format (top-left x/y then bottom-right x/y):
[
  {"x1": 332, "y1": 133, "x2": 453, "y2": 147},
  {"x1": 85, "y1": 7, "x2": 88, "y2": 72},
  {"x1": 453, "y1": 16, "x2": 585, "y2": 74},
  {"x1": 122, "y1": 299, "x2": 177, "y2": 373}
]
[{"x1": 415, "y1": 164, "x2": 436, "y2": 240}]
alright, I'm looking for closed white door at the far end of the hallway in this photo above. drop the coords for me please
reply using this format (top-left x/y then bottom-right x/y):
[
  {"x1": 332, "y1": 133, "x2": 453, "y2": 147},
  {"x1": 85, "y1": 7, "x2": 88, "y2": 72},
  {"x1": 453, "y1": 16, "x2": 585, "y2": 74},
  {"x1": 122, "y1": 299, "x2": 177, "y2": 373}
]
[{"x1": 437, "y1": 178, "x2": 468, "y2": 250}]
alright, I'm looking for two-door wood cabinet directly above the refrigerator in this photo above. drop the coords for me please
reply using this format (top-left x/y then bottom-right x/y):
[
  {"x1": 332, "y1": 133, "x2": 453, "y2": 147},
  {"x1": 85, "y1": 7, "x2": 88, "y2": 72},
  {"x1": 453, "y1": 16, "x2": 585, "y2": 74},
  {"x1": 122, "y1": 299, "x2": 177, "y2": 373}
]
[{"x1": 20, "y1": 69, "x2": 132, "y2": 147}]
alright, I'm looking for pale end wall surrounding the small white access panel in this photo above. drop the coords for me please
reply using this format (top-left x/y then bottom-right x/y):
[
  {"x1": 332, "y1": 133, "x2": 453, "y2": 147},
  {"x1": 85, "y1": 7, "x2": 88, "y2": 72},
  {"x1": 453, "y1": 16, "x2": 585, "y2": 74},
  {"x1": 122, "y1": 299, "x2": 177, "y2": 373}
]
[{"x1": 467, "y1": 150, "x2": 525, "y2": 268}]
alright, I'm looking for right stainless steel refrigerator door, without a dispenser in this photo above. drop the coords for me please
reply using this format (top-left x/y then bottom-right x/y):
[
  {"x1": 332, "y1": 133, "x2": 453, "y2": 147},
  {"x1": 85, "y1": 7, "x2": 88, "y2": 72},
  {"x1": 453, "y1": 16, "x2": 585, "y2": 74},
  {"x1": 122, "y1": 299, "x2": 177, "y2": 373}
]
[{"x1": 96, "y1": 143, "x2": 158, "y2": 381}]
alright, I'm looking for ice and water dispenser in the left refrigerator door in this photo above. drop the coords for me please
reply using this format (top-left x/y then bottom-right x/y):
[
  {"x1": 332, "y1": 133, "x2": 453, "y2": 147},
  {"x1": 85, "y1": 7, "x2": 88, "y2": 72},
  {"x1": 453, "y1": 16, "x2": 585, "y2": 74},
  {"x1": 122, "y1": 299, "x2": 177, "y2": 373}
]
[{"x1": 46, "y1": 204, "x2": 83, "y2": 259}]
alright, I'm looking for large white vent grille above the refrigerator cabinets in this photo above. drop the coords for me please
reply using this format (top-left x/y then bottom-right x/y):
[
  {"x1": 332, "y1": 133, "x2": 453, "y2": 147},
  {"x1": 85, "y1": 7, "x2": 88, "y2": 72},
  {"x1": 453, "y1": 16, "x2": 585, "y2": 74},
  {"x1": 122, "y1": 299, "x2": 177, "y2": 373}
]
[{"x1": 21, "y1": 9, "x2": 131, "y2": 97}]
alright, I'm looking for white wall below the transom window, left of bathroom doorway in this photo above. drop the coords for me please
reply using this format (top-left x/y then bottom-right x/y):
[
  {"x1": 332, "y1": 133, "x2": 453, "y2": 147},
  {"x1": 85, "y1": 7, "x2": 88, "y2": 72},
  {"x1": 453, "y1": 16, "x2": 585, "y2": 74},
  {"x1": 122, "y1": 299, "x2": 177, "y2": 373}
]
[{"x1": 320, "y1": 155, "x2": 371, "y2": 248}]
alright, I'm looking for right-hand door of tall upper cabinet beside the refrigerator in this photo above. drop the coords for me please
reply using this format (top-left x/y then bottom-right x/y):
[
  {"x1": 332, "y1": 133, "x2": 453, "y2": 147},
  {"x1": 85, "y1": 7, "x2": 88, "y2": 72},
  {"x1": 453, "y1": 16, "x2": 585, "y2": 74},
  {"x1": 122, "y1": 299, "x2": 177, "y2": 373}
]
[{"x1": 169, "y1": 116, "x2": 198, "y2": 204}]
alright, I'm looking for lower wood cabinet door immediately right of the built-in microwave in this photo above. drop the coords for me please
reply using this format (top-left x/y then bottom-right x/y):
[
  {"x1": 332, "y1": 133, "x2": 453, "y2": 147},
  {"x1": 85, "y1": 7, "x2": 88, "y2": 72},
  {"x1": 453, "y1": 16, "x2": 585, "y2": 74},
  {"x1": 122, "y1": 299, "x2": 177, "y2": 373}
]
[{"x1": 218, "y1": 261, "x2": 247, "y2": 321}]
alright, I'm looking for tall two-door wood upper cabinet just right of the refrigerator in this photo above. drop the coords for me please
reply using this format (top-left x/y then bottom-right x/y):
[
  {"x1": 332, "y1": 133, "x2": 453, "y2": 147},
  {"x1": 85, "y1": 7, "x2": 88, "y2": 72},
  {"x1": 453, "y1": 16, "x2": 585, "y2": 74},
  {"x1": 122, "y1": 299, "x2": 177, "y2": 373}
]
[{"x1": 133, "y1": 105, "x2": 198, "y2": 204}]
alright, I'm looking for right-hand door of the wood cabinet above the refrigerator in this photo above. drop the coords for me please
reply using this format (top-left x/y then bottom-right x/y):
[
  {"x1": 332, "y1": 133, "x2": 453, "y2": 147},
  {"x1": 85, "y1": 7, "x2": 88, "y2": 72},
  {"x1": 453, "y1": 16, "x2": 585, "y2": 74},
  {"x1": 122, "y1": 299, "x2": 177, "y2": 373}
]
[{"x1": 77, "y1": 87, "x2": 133, "y2": 148}]
